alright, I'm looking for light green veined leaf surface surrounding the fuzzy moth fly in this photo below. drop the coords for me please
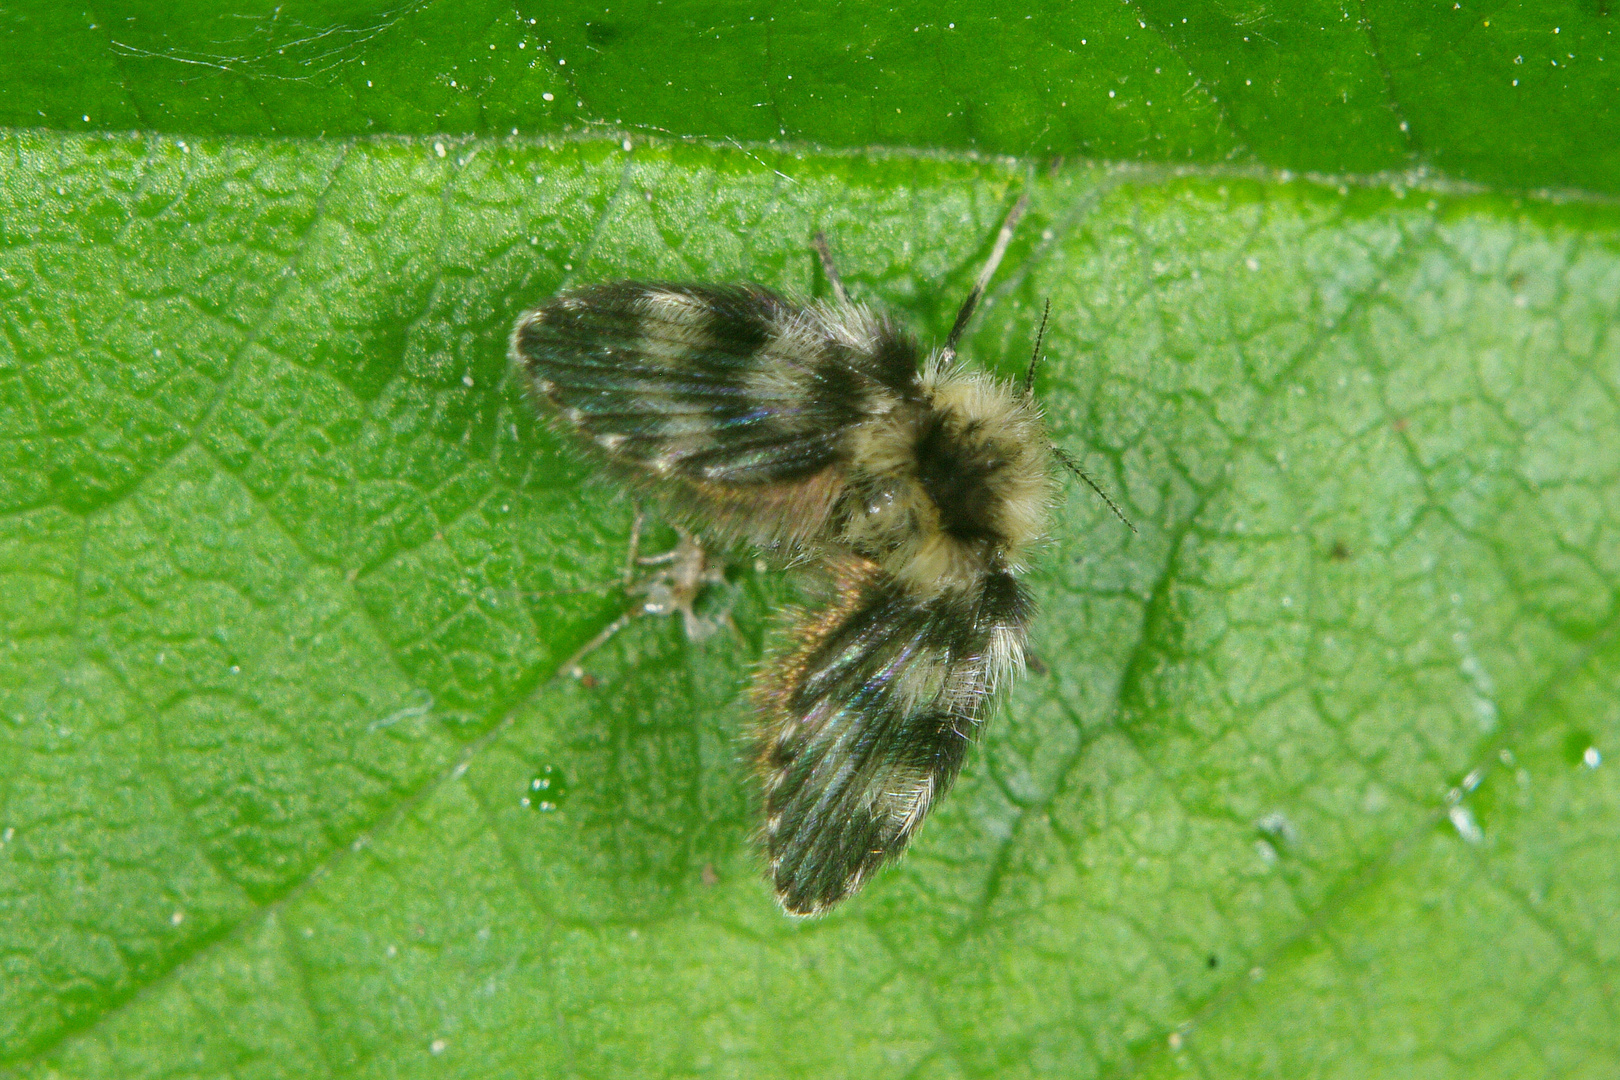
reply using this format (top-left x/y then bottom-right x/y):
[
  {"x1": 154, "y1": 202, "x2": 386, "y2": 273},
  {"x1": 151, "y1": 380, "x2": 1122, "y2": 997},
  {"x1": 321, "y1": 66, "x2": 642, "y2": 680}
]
[{"x1": 0, "y1": 134, "x2": 1620, "y2": 1078}]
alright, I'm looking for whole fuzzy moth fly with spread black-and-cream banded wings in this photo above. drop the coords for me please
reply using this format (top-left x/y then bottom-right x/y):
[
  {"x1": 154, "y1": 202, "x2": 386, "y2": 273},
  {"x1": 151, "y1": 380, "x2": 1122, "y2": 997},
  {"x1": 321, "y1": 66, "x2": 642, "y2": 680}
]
[{"x1": 512, "y1": 199, "x2": 1118, "y2": 915}]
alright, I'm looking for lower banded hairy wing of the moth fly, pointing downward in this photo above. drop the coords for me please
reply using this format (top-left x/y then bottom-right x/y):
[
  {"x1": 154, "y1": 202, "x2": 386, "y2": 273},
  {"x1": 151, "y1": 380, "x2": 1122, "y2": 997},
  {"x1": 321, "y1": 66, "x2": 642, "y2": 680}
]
[{"x1": 755, "y1": 557, "x2": 1034, "y2": 915}]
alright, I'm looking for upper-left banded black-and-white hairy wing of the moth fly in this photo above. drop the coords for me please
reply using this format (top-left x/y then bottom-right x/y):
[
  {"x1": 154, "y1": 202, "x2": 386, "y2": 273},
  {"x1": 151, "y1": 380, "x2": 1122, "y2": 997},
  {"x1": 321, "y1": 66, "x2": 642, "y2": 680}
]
[{"x1": 512, "y1": 282, "x2": 917, "y2": 544}]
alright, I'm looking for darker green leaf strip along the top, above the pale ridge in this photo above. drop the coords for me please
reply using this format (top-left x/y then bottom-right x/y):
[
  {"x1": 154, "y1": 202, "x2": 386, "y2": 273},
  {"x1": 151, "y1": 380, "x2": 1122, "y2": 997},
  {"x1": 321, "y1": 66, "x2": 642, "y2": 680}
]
[{"x1": 0, "y1": 0, "x2": 1620, "y2": 194}]
